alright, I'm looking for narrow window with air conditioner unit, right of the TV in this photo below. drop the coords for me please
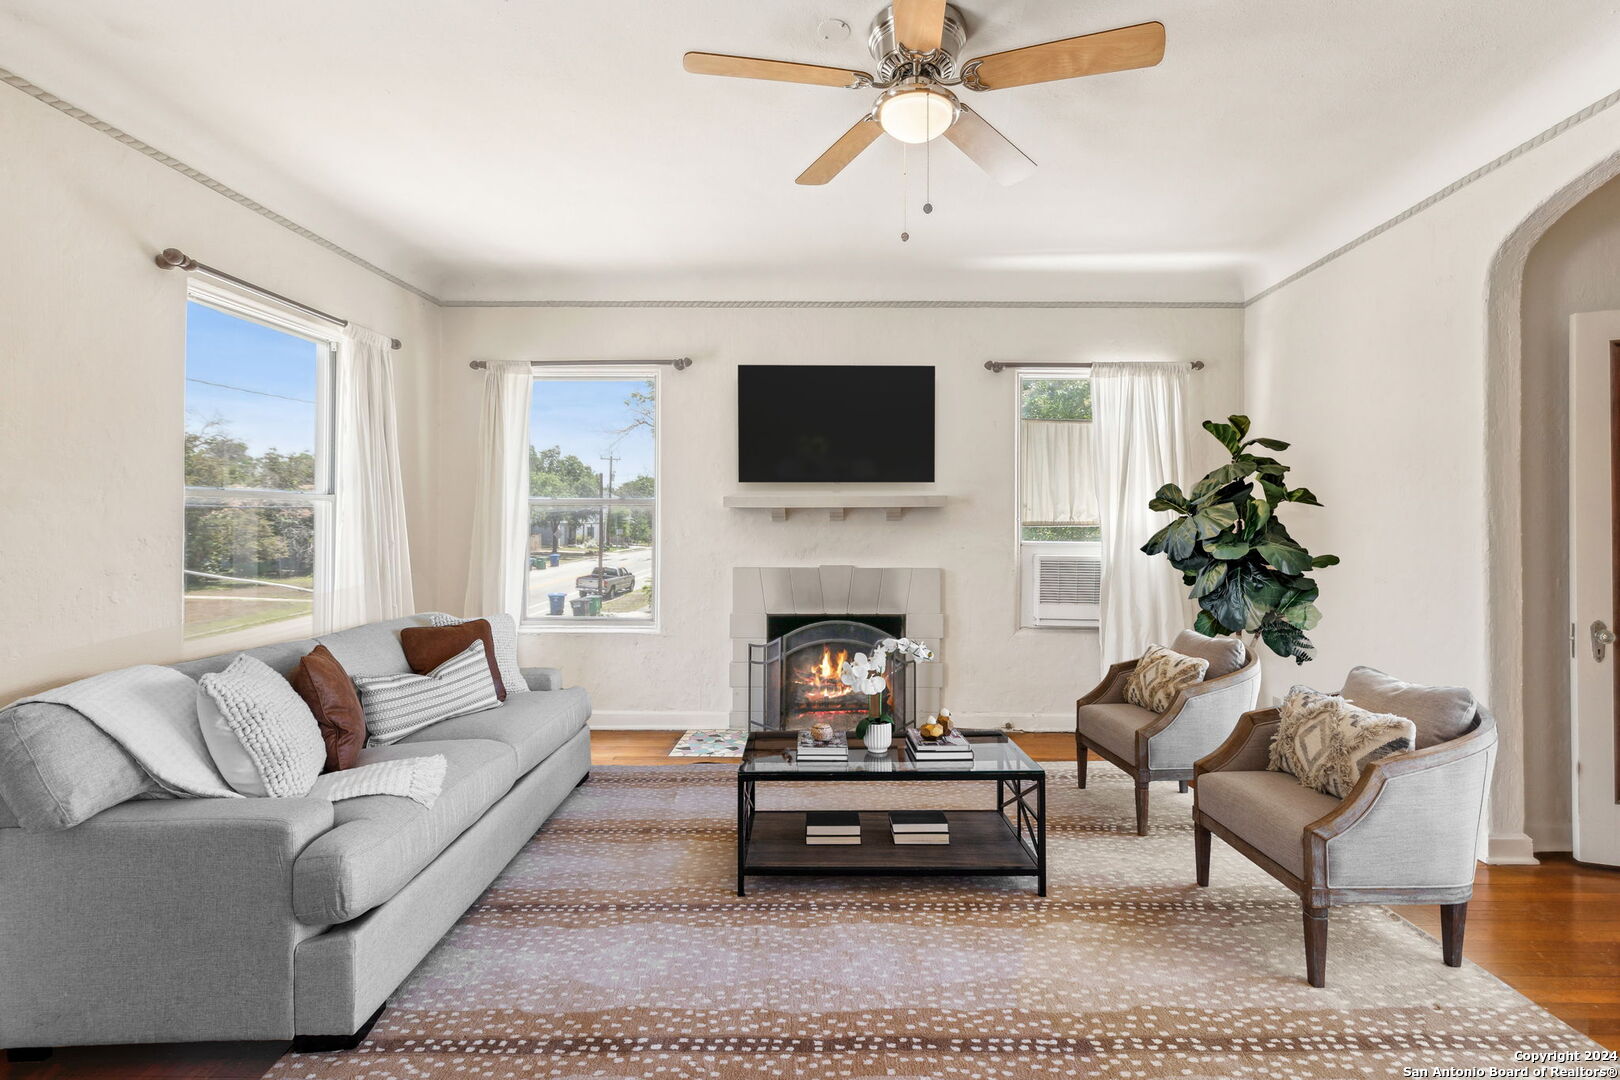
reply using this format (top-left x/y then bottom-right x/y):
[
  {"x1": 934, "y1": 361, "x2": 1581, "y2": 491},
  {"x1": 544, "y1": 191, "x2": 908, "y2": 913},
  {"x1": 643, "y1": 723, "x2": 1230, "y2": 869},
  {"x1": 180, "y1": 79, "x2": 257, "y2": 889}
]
[{"x1": 1017, "y1": 372, "x2": 1102, "y2": 627}]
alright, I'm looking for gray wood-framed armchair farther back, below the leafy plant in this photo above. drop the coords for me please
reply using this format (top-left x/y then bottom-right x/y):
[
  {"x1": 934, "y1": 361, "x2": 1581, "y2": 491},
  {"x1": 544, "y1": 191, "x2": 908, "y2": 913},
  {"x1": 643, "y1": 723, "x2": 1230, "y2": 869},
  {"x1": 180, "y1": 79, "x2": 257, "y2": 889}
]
[{"x1": 1074, "y1": 630, "x2": 1260, "y2": 836}]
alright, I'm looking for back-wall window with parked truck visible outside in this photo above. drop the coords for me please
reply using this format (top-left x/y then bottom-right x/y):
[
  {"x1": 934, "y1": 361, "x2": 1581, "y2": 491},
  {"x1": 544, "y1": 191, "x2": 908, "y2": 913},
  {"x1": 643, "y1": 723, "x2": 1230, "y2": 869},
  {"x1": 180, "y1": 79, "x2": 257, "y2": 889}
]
[{"x1": 523, "y1": 369, "x2": 658, "y2": 630}]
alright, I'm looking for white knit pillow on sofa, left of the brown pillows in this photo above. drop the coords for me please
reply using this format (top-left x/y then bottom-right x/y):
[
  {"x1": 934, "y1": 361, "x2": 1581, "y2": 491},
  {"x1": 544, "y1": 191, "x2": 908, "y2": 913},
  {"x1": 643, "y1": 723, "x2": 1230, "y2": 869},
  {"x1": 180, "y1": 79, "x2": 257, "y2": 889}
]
[{"x1": 198, "y1": 653, "x2": 326, "y2": 798}]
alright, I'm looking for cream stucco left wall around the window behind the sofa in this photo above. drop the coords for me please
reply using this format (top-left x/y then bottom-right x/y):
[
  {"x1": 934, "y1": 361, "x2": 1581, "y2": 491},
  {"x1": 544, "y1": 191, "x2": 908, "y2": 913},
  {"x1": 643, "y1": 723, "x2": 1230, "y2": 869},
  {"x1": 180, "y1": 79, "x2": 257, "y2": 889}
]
[{"x1": 0, "y1": 87, "x2": 437, "y2": 701}]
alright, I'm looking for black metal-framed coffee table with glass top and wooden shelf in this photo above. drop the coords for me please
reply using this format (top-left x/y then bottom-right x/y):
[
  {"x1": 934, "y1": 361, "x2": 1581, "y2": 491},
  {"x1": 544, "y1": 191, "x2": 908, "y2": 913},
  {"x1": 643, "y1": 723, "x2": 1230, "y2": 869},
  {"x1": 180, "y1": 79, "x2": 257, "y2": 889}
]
[{"x1": 737, "y1": 730, "x2": 1047, "y2": 895}]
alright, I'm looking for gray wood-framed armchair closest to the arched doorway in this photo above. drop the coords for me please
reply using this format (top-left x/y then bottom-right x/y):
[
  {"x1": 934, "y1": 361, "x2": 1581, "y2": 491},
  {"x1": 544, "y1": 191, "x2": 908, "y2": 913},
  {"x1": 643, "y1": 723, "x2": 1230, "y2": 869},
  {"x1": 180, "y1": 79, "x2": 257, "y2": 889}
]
[{"x1": 1192, "y1": 667, "x2": 1497, "y2": 986}]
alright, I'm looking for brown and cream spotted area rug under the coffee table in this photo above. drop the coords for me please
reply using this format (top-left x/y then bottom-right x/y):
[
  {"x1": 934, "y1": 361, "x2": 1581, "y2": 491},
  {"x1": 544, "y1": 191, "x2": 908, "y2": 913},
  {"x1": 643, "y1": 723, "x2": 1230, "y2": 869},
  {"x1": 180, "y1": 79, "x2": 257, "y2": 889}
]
[{"x1": 267, "y1": 764, "x2": 1596, "y2": 1080}]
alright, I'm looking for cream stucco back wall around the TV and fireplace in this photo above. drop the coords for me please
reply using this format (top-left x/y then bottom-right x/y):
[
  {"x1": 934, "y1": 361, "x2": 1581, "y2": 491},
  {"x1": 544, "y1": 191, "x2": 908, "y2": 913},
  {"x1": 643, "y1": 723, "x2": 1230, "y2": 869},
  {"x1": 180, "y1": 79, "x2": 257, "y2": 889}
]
[{"x1": 434, "y1": 308, "x2": 1243, "y2": 727}]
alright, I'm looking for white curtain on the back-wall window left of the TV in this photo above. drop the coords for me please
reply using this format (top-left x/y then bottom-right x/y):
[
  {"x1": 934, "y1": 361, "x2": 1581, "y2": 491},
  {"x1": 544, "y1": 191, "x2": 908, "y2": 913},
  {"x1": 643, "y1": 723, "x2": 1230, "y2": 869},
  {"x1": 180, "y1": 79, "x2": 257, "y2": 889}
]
[{"x1": 462, "y1": 359, "x2": 535, "y2": 620}]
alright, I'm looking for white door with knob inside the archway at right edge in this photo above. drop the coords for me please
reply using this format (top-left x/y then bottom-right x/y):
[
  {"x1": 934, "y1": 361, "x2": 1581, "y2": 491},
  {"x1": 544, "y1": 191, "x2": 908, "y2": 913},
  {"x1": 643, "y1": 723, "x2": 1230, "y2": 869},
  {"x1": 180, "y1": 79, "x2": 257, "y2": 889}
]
[{"x1": 1570, "y1": 311, "x2": 1620, "y2": 866}]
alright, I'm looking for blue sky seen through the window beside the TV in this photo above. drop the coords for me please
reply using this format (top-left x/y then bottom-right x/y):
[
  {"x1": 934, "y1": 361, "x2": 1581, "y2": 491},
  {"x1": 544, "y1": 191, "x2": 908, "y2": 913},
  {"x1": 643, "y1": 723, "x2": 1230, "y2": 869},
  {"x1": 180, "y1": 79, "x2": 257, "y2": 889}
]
[{"x1": 528, "y1": 379, "x2": 653, "y2": 484}]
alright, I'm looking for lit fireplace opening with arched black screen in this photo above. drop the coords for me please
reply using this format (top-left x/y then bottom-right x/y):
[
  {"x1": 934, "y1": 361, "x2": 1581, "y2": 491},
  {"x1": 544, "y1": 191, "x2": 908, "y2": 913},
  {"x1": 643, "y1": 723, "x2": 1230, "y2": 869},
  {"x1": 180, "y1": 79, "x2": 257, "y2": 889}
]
[{"x1": 748, "y1": 615, "x2": 917, "y2": 730}]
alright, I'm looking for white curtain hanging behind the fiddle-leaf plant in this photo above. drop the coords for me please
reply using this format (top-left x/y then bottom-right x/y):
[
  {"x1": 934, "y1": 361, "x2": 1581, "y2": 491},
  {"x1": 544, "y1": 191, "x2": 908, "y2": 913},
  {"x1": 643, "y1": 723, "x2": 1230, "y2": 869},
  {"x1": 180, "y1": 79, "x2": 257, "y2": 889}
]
[{"x1": 1092, "y1": 364, "x2": 1191, "y2": 665}]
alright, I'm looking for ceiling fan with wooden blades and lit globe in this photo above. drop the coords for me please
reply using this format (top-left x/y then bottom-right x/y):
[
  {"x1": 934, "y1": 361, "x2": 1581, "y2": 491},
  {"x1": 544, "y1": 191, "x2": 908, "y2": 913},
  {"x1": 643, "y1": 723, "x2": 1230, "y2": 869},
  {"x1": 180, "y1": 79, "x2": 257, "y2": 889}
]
[{"x1": 685, "y1": 0, "x2": 1165, "y2": 185}]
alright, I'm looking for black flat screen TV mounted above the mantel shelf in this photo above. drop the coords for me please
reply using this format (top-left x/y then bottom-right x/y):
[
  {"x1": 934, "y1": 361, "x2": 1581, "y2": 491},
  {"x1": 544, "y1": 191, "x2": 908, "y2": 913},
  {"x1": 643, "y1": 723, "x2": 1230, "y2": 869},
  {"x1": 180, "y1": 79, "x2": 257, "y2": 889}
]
[{"x1": 737, "y1": 364, "x2": 933, "y2": 484}]
